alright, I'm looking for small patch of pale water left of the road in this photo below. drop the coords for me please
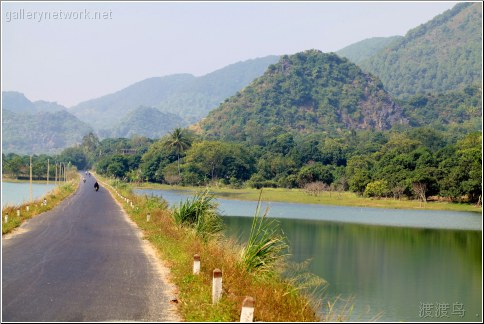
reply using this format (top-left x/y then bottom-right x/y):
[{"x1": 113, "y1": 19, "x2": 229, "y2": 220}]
[{"x1": 2, "y1": 181, "x2": 55, "y2": 208}]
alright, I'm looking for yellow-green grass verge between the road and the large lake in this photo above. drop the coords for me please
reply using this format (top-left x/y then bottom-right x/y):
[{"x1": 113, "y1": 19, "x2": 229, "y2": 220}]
[{"x1": 98, "y1": 177, "x2": 328, "y2": 322}]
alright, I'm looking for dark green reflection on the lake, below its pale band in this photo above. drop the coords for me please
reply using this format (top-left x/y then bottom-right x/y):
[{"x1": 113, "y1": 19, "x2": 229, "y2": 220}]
[{"x1": 224, "y1": 217, "x2": 482, "y2": 321}]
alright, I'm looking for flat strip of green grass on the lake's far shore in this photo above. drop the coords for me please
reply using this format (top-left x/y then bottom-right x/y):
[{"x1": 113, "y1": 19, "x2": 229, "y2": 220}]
[{"x1": 137, "y1": 183, "x2": 482, "y2": 213}]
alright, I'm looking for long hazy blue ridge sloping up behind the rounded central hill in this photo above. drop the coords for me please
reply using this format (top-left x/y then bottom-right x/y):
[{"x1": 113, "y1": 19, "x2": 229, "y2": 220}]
[{"x1": 70, "y1": 56, "x2": 278, "y2": 132}]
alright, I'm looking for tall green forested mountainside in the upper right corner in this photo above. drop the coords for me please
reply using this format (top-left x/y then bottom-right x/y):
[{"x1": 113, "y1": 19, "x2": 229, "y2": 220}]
[{"x1": 359, "y1": 2, "x2": 482, "y2": 98}]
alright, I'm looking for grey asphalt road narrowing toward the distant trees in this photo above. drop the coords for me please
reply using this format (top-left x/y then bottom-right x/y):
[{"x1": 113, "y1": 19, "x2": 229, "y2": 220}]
[{"x1": 2, "y1": 176, "x2": 179, "y2": 322}]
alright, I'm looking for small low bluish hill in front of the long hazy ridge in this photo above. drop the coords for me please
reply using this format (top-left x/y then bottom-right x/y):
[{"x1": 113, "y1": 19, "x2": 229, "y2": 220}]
[{"x1": 109, "y1": 106, "x2": 184, "y2": 138}]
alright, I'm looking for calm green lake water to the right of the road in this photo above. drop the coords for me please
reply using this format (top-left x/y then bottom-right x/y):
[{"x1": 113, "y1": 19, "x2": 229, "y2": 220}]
[{"x1": 138, "y1": 190, "x2": 482, "y2": 322}]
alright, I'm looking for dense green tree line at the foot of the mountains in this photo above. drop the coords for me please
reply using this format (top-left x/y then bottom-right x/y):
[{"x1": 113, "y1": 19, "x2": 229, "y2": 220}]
[{"x1": 2, "y1": 127, "x2": 482, "y2": 202}]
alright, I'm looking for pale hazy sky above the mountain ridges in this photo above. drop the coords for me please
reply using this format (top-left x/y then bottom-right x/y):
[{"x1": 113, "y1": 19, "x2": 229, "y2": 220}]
[{"x1": 2, "y1": 1, "x2": 462, "y2": 107}]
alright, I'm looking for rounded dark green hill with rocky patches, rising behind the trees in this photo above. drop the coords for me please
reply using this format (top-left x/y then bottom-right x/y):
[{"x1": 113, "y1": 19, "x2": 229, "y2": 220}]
[{"x1": 199, "y1": 50, "x2": 407, "y2": 143}]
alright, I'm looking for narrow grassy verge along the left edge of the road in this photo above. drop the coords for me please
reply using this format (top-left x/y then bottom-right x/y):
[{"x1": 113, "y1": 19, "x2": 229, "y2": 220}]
[{"x1": 2, "y1": 171, "x2": 80, "y2": 235}]
